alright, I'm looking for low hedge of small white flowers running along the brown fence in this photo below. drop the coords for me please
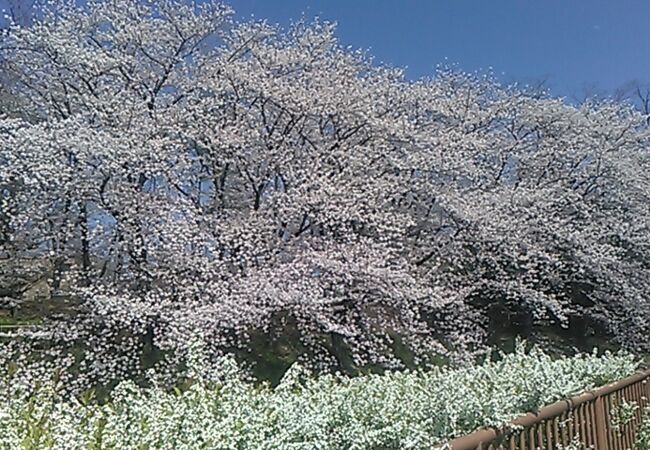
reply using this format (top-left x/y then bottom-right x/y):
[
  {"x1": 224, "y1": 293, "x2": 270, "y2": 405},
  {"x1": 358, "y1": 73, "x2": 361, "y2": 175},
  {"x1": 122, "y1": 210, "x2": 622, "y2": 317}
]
[{"x1": 0, "y1": 345, "x2": 637, "y2": 450}]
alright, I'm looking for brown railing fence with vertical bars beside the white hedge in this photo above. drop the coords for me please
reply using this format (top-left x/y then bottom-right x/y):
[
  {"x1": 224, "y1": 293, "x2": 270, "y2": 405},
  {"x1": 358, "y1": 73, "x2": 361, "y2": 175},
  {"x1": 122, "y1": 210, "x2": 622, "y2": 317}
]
[{"x1": 449, "y1": 370, "x2": 650, "y2": 450}]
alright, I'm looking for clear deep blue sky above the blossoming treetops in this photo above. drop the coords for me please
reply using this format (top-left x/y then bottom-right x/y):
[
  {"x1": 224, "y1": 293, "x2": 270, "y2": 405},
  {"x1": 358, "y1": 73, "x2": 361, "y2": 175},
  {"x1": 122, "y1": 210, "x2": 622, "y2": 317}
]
[{"x1": 229, "y1": 0, "x2": 650, "y2": 100}]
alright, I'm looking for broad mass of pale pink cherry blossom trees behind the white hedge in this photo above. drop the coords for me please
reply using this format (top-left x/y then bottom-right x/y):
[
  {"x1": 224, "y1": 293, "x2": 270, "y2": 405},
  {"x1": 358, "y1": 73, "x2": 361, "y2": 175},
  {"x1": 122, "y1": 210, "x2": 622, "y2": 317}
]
[{"x1": 0, "y1": 0, "x2": 650, "y2": 388}]
